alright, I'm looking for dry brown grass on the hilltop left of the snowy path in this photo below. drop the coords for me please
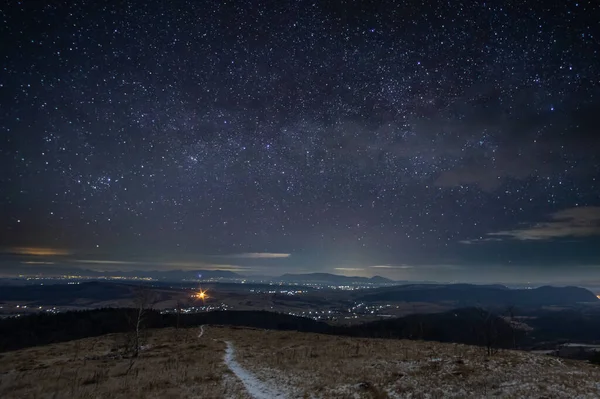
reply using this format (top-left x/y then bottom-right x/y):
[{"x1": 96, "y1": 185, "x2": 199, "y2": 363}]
[{"x1": 0, "y1": 329, "x2": 251, "y2": 399}]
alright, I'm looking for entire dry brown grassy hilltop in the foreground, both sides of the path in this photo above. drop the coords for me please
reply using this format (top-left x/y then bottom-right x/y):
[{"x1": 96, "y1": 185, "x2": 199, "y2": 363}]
[{"x1": 0, "y1": 326, "x2": 600, "y2": 399}]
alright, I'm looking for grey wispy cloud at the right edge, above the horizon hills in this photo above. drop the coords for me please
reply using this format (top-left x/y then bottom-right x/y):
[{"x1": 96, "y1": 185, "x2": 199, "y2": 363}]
[{"x1": 468, "y1": 206, "x2": 600, "y2": 244}]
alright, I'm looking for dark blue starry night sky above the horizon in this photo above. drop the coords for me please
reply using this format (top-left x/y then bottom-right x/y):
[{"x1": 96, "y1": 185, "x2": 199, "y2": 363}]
[{"x1": 0, "y1": 0, "x2": 600, "y2": 281}]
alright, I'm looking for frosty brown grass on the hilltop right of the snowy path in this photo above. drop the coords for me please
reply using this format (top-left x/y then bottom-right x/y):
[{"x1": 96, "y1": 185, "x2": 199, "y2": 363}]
[{"x1": 205, "y1": 327, "x2": 600, "y2": 399}]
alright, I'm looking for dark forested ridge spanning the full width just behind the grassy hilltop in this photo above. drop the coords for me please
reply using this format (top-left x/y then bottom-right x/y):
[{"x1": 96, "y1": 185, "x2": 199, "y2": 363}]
[{"x1": 0, "y1": 308, "x2": 600, "y2": 352}]
